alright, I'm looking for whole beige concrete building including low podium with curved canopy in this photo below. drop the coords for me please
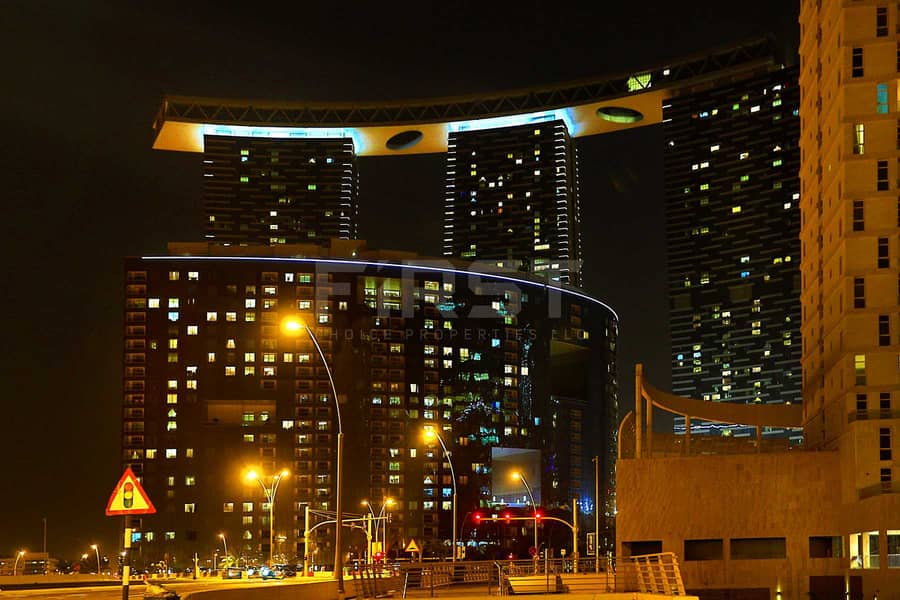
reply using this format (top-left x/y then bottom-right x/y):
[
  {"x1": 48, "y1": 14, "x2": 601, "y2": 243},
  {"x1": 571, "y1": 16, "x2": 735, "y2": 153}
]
[{"x1": 617, "y1": 0, "x2": 900, "y2": 600}]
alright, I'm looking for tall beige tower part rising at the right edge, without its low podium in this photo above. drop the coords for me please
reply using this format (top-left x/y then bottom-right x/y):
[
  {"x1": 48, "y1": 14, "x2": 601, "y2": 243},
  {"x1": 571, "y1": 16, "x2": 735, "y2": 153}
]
[{"x1": 800, "y1": 0, "x2": 900, "y2": 572}]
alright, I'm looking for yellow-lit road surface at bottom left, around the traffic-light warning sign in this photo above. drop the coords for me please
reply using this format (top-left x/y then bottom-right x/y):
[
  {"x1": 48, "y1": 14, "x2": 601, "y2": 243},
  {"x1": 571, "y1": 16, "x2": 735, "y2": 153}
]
[{"x1": 0, "y1": 577, "x2": 325, "y2": 600}]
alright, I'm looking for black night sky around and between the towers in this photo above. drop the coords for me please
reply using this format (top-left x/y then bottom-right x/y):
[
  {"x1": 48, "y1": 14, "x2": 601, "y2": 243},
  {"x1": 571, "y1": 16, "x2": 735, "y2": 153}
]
[{"x1": 0, "y1": 0, "x2": 798, "y2": 557}]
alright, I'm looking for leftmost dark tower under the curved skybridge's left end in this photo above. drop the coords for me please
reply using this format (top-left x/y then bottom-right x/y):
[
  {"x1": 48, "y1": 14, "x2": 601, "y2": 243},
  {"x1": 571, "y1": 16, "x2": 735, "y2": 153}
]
[{"x1": 203, "y1": 135, "x2": 359, "y2": 245}]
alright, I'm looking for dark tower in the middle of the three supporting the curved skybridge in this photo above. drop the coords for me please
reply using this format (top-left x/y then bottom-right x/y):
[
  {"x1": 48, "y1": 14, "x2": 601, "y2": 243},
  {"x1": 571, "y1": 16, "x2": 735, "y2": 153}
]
[{"x1": 444, "y1": 119, "x2": 581, "y2": 285}]
